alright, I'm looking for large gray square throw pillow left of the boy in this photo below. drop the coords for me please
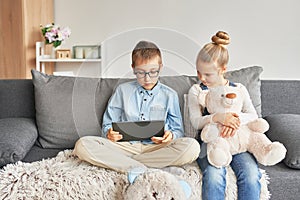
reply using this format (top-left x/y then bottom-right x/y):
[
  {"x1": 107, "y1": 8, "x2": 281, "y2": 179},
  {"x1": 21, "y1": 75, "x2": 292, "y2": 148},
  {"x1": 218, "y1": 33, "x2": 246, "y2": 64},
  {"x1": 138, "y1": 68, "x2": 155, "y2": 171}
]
[{"x1": 31, "y1": 70, "x2": 102, "y2": 149}]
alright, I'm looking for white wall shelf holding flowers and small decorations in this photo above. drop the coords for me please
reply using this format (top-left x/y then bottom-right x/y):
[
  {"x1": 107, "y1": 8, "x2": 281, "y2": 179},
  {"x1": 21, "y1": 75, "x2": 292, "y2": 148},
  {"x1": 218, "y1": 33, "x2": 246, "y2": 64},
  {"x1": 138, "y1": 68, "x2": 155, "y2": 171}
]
[{"x1": 36, "y1": 42, "x2": 101, "y2": 73}]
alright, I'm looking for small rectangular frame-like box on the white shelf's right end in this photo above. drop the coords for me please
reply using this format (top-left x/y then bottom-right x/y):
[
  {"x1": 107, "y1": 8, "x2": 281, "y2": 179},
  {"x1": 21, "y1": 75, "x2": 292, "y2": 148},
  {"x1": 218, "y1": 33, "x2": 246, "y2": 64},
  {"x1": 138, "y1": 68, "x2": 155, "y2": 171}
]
[{"x1": 73, "y1": 45, "x2": 101, "y2": 59}]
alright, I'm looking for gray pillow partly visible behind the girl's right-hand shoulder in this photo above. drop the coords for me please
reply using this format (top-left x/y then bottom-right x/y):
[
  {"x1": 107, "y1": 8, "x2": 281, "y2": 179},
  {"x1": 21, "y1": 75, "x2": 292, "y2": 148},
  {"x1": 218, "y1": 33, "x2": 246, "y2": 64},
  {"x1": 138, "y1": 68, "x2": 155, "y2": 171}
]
[{"x1": 225, "y1": 66, "x2": 263, "y2": 117}]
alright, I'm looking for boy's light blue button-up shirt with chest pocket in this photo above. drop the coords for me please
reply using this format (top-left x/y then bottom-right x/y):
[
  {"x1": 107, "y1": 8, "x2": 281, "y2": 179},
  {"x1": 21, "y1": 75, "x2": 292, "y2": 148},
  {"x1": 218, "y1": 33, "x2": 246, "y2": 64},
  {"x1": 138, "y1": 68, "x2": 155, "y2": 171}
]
[{"x1": 102, "y1": 81, "x2": 184, "y2": 139}]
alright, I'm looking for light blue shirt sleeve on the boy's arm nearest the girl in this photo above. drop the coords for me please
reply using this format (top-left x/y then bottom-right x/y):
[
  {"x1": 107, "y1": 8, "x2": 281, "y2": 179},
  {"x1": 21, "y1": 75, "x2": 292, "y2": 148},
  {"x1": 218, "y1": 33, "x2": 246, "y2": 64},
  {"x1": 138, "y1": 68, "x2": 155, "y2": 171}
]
[{"x1": 166, "y1": 93, "x2": 184, "y2": 139}]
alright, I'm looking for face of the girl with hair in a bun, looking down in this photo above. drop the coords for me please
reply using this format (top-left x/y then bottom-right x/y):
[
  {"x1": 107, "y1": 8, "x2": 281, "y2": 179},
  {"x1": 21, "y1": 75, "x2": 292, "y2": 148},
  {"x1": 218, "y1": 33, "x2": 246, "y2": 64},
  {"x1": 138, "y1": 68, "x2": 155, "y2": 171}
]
[{"x1": 197, "y1": 61, "x2": 226, "y2": 87}]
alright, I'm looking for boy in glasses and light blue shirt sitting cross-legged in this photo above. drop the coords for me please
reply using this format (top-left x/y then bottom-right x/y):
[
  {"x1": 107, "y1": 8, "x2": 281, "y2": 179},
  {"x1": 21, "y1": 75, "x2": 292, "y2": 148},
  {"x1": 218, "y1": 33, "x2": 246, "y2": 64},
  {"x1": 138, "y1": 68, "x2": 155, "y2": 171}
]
[{"x1": 74, "y1": 41, "x2": 200, "y2": 192}]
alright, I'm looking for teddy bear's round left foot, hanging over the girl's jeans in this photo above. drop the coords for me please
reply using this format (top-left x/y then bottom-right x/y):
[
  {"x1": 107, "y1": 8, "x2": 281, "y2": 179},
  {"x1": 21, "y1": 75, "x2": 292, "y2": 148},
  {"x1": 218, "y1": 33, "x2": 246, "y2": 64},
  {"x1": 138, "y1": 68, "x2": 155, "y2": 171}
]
[{"x1": 207, "y1": 148, "x2": 232, "y2": 168}]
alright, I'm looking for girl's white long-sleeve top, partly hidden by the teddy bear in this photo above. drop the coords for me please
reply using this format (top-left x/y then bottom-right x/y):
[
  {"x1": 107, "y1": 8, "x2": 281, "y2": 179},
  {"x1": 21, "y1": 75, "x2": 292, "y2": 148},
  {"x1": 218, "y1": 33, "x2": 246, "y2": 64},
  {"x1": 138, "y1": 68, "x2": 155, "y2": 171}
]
[{"x1": 188, "y1": 82, "x2": 258, "y2": 130}]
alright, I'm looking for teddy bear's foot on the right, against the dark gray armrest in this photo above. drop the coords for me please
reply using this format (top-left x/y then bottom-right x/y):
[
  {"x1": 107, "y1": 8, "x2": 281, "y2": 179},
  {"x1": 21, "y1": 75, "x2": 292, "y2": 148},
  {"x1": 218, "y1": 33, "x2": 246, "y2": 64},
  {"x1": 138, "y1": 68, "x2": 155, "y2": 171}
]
[{"x1": 261, "y1": 142, "x2": 286, "y2": 166}]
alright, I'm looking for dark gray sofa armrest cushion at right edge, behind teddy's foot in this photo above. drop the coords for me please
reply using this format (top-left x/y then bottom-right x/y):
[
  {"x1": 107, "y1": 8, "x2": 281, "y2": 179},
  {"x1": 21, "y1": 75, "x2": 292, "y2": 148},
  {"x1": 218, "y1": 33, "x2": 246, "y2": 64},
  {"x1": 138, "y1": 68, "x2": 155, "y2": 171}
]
[{"x1": 265, "y1": 114, "x2": 300, "y2": 169}]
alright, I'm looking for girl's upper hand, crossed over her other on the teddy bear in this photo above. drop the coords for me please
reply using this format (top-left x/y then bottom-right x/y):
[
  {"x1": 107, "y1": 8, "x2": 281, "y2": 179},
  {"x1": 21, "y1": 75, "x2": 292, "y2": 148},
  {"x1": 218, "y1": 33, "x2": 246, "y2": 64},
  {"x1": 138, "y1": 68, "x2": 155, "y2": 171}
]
[{"x1": 213, "y1": 113, "x2": 241, "y2": 129}]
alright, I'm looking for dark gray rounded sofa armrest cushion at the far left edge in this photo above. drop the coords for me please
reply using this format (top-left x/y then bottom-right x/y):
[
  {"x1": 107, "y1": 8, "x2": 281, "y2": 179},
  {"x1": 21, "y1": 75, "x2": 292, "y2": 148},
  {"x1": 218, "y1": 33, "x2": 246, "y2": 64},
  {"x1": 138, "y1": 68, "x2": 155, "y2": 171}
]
[{"x1": 0, "y1": 118, "x2": 38, "y2": 167}]
